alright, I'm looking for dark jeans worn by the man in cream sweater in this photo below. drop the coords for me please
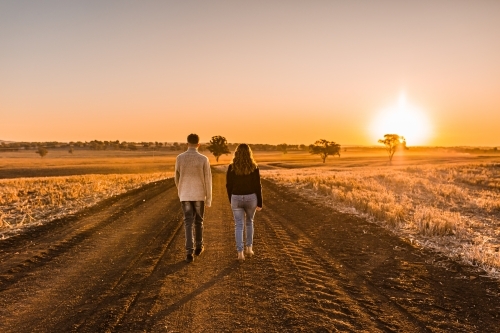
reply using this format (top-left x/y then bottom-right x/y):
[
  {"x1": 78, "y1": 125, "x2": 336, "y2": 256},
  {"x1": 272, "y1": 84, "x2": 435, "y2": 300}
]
[{"x1": 181, "y1": 201, "x2": 205, "y2": 254}]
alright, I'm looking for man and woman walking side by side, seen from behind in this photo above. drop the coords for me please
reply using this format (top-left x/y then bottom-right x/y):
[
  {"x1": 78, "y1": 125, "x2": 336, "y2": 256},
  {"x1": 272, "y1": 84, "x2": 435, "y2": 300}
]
[{"x1": 175, "y1": 134, "x2": 262, "y2": 262}]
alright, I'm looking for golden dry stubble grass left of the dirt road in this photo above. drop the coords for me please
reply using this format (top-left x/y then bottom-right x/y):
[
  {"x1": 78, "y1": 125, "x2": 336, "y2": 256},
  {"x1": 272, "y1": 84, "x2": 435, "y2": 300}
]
[{"x1": 0, "y1": 173, "x2": 172, "y2": 237}]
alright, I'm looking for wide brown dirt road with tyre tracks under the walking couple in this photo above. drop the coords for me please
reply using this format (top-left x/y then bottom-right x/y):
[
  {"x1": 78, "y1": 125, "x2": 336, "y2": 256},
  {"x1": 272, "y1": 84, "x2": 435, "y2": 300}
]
[{"x1": 0, "y1": 173, "x2": 500, "y2": 332}]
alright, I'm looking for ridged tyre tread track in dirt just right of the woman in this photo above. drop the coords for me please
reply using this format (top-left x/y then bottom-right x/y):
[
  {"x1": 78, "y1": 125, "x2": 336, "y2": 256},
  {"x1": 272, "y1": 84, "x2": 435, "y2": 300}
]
[{"x1": 258, "y1": 204, "x2": 428, "y2": 332}]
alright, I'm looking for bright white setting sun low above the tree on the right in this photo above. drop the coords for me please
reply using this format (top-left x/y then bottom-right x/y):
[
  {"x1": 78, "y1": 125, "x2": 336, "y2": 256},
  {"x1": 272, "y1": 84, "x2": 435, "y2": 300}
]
[{"x1": 370, "y1": 94, "x2": 432, "y2": 146}]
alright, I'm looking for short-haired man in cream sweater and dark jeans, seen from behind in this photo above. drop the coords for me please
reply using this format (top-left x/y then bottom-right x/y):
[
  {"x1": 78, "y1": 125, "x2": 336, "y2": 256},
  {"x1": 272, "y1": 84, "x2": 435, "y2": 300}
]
[{"x1": 175, "y1": 134, "x2": 212, "y2": 262}]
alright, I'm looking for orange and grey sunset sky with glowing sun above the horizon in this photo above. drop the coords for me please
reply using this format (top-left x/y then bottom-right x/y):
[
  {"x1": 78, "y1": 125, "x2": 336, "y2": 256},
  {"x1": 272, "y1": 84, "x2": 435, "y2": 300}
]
[{"x1": 0, "y1": 0, "x2": 500, "y2": 146}]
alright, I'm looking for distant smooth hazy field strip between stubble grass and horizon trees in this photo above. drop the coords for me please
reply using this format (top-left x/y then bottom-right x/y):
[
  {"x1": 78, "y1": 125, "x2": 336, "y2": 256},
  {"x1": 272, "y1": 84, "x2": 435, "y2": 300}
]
[{"x1": 0, "y1": 147, "x2": 500, "y2": 179}]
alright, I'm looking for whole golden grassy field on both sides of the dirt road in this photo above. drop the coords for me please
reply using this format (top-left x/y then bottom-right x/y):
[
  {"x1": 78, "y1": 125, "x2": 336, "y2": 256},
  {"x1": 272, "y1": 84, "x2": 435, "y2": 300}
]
[{"x1": 0, "y1": 147, "x2": 500, "y2": 276}]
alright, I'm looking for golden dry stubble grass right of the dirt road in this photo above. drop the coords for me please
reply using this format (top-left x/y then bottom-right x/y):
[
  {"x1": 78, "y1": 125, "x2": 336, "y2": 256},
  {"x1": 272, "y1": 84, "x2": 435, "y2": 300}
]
[{"x1": 263, "y1": 163, "x2": 500, "y2": 276}]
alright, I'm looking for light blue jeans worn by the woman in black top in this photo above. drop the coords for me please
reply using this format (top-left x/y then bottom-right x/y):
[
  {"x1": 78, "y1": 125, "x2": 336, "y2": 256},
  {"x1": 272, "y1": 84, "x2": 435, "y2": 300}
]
[{"x1": 231, "y1": 193, "x2": 257, "y2": 252}]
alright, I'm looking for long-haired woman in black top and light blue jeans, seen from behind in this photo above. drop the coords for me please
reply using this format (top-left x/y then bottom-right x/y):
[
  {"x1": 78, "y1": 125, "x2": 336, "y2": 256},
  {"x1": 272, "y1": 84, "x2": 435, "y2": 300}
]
[{"x1": 226, "y1": 143, "x2": 262, "y2": 260}]
